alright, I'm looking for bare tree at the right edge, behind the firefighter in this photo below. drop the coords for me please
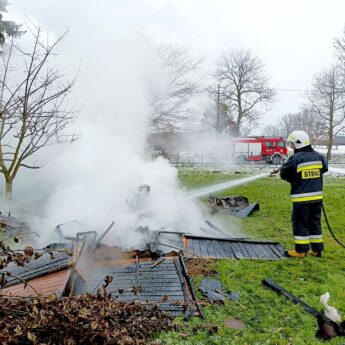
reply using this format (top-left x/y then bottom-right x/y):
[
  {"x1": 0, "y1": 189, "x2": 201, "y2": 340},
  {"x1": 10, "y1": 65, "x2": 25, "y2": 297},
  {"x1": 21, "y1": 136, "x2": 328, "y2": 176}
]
[{"x1": 309, "y1": 66, "x2": 345, "y2": 159}]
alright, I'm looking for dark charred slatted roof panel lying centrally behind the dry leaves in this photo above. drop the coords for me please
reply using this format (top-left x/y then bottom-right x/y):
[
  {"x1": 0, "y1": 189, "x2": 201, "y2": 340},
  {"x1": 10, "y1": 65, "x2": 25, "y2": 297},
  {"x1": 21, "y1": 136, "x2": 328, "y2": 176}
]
[{"x1": 87, "y1": 258, "x2": 199, "y2": 316}]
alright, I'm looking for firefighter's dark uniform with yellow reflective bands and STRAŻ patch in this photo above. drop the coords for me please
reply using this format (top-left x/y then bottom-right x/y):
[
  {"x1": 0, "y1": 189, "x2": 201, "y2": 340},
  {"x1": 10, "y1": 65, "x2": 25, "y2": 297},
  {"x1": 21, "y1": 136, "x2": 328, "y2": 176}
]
[{"x1": 280, "y1": 145, "x2": 328, "y2": 253}]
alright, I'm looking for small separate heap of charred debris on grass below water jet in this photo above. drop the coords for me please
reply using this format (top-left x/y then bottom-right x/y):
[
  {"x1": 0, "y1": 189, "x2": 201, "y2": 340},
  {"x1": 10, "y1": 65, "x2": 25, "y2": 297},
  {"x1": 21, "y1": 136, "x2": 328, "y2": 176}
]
[{"x1": 208, "y1": 196, "x2": 260, "y2": 218}]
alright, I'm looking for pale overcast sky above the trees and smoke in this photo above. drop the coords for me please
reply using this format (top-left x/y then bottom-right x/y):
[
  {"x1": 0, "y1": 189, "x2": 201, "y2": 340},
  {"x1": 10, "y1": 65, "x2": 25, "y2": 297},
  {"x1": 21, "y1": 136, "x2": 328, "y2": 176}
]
[{"x1": 9, "y1": 0, "x2": 345, "y2": 130}]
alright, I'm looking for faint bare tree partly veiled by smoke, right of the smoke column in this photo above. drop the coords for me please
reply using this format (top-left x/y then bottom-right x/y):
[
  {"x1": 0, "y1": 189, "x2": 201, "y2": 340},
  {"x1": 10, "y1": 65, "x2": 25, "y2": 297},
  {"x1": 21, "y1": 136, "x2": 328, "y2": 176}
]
[{"x1": 151, "y1": 44, "x2": 202, "y2": 131}]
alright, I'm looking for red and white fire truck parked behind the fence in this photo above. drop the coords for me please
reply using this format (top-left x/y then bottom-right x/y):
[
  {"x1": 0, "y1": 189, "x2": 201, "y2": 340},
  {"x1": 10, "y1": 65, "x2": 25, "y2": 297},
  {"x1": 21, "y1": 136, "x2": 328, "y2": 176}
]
[{"x1": 229, "y1": 137, "x2": 287, "y2": 165}]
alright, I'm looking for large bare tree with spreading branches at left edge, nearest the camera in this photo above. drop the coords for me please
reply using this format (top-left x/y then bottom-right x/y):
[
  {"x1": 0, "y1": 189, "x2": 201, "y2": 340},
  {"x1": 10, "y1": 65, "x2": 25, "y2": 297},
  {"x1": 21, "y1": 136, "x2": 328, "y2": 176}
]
[{"x1": 0, "y1": 27, "x2": 76, "y2": 197}]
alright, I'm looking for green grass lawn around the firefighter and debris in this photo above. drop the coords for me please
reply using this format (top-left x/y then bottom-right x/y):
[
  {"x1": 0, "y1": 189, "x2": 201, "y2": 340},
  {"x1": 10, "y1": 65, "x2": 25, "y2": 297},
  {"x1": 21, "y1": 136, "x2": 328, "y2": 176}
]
[{"x1": 158, "y1": 171, "x2": 345, "y2": 345}]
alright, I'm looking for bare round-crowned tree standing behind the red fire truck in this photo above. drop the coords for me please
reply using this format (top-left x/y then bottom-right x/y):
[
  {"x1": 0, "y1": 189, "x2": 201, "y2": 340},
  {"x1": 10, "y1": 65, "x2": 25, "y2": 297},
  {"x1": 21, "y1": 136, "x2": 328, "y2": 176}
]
[{"x1": 214, "y1": 50, "x2": 275, "y2": 136}]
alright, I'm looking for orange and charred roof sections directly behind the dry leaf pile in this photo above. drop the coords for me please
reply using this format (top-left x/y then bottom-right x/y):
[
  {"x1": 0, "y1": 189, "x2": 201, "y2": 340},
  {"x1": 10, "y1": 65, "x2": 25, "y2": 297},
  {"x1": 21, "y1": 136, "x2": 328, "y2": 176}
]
[{"x1": 0, "y1": 226, "x2": 203, "y2": 318}]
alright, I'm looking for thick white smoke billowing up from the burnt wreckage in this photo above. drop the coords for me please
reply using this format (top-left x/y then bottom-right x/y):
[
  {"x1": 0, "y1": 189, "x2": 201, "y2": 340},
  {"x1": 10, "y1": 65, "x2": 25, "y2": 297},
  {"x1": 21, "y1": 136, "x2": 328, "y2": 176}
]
[{"x1": 4, "y1": 0, "x2": 207, "y2": 247}]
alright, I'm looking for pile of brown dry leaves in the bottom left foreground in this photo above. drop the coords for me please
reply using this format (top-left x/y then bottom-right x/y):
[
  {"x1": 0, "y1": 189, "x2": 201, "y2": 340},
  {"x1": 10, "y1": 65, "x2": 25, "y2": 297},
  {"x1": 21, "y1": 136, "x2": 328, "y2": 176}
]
[{"x1": 0, "y1": 293, "x2": 175, "y2": 345}]
